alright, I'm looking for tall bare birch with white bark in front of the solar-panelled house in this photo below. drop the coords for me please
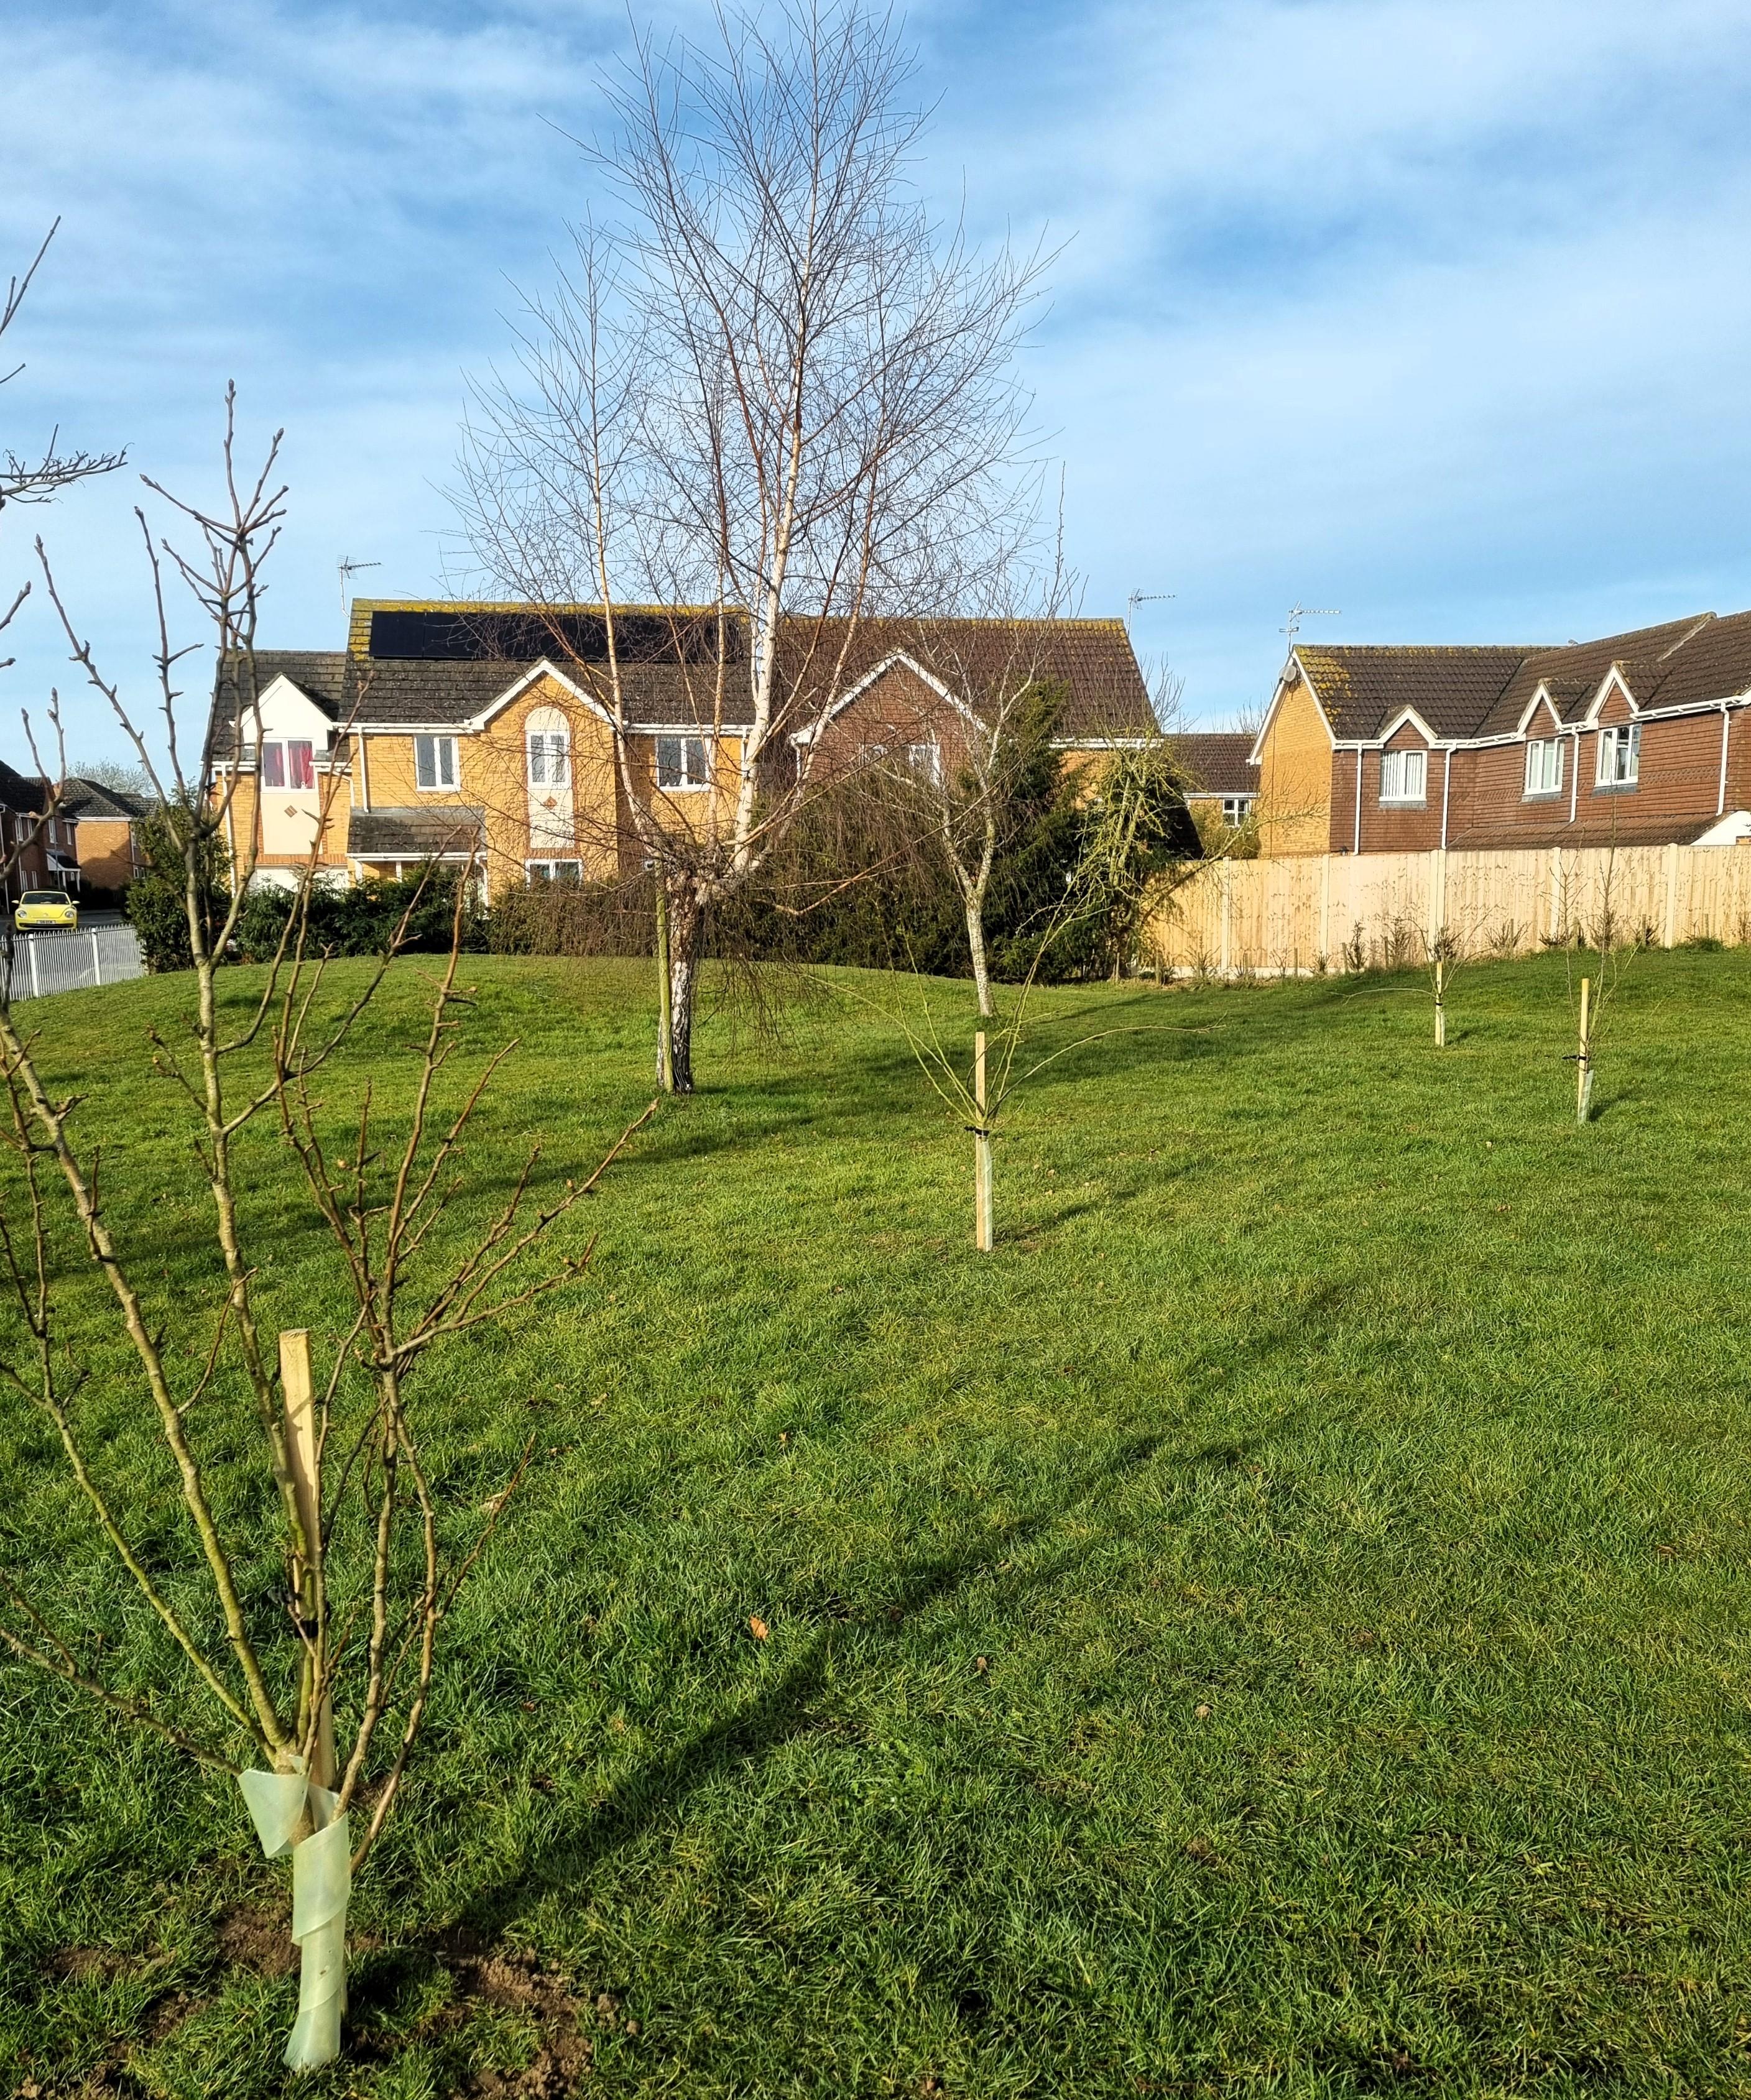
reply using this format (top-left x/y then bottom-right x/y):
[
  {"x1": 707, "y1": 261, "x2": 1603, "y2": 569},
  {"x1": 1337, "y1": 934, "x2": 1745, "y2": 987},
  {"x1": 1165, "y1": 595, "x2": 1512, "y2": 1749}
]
[{"x1": 456, "y1": 0, "x2": 1043, "y2": 1092}]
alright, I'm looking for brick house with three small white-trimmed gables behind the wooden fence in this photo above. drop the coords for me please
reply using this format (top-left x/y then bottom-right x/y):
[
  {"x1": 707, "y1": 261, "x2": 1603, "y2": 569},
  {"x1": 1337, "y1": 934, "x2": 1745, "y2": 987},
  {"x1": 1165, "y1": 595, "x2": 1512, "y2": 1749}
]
[{"x1": 1251, "y1": 613, "x2": 1751, "y2": 855}]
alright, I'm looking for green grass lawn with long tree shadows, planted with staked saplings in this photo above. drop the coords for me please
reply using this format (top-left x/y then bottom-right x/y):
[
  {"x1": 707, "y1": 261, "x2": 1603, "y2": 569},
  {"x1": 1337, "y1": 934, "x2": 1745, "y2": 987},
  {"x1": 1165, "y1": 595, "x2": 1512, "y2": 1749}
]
[{"x1": 0, "y1": 951, "x2": 1751, "y2": 2100}]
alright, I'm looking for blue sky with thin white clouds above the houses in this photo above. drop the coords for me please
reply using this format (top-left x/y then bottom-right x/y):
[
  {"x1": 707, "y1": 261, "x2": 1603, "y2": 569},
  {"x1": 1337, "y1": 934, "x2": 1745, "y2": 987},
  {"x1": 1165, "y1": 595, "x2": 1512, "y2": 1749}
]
[{"x1": 0, "y1": 0, "x2": 1751, "y2": 762}]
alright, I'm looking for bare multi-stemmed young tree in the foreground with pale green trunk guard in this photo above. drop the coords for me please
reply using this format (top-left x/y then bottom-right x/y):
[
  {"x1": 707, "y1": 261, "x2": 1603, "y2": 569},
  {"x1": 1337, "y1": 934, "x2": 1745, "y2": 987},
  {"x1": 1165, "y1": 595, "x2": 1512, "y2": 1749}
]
[{"x1": 0, "y1": 409, "x2": 636, "y2": 2066}]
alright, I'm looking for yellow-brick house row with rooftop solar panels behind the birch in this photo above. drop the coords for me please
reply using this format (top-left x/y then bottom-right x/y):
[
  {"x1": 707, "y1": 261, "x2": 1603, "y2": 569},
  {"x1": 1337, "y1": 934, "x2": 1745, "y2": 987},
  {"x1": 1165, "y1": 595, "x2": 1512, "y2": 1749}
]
[{"x1": 214, "y1": 599, "x2": 1155, "y2": 896}]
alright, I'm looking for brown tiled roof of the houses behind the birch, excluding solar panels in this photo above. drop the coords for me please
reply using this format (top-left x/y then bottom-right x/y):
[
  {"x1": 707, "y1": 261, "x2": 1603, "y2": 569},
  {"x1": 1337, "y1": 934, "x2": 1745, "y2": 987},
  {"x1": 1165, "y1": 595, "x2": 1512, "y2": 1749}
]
[{"x1": 214, "y1": 620, "x2": 1155, "y2": 758}]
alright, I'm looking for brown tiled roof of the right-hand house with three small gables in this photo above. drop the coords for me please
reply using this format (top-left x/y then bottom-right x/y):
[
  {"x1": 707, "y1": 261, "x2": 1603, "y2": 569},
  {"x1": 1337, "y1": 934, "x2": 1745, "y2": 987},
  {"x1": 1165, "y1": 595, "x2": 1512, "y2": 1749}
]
[{"x1": 1295, "y1": 613, "x2": 1751, "y2": 739}]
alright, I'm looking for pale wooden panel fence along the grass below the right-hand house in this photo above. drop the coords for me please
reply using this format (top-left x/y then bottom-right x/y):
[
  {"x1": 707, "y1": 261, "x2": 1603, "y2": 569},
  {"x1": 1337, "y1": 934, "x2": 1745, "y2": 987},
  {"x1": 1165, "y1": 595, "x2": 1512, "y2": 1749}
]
[{"x1": 1144, "y1": 846, "x2": 1751, "y2": 977}]
